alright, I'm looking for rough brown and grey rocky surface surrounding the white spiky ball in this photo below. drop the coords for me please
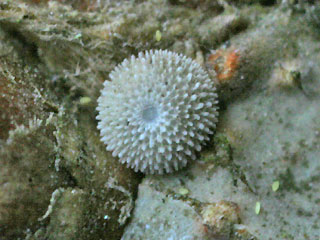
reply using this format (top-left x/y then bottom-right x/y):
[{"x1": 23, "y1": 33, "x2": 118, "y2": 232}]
[{"x1": 0, "y1": 0, "x2": 320, "y2": 240}]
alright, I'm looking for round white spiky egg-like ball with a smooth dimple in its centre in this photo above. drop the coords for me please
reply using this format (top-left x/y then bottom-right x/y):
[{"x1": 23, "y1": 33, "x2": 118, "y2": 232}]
[{"x1": 97, "y1": 50, "x2": 218, "y2": 174}]
